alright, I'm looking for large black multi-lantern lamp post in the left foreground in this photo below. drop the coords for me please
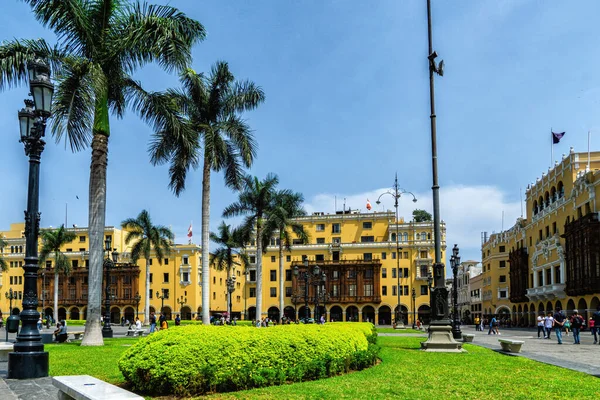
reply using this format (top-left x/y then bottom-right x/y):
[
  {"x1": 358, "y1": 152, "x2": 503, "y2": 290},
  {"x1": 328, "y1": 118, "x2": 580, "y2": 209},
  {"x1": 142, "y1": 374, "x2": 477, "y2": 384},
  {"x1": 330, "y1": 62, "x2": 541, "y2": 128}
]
[{"x1": 8, "y1": 60, "x2": 54, "y2": 379}]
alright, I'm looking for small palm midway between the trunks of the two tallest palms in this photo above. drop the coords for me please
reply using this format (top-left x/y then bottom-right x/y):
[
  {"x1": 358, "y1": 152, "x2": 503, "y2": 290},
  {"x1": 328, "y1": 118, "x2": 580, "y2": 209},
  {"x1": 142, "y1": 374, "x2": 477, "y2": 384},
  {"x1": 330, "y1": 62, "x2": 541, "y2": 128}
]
[{"x1": 121, "y1": 210, "x2": 175, "y2": 324}]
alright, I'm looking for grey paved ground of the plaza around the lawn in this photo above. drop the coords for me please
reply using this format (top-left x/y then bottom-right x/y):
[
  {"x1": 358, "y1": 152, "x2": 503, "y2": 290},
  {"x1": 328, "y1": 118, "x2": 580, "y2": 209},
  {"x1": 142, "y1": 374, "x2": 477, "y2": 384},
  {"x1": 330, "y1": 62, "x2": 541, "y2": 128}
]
[{"x1": 0, "y1": 326, "x2": 600, "y2": 400}]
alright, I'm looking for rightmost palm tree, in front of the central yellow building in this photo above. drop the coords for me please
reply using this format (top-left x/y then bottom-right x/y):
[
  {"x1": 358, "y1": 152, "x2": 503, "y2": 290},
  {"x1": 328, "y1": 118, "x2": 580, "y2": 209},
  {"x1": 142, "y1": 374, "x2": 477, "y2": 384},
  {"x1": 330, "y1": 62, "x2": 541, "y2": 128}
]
[{"x1": 265, "y1": 190, "x2": 309, "y2": 324}]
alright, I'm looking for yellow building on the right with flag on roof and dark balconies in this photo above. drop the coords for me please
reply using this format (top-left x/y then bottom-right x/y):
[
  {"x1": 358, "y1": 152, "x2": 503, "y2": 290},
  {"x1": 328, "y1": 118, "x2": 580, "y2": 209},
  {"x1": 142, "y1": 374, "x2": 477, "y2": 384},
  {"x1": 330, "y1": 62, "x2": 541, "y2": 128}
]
[{"x1": 482, "y1": 149, "x2": 600, "y2": 326}]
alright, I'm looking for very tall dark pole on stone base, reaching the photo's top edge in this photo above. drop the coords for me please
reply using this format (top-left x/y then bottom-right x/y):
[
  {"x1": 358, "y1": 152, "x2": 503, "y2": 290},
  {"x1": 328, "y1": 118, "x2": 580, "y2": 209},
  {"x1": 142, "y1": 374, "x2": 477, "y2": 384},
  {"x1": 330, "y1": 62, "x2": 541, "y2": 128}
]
[{"x1": 421, "y1": 0, "x2": 462, "y2": 352}]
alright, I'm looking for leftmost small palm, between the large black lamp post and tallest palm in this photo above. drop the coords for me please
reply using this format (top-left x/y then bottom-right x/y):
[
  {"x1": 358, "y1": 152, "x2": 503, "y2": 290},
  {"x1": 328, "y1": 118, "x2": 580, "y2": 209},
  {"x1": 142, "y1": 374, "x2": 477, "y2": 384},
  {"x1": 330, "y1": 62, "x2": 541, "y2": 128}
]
[{"x1": 40, "y1": 225, "x2": 77, "y2": 321}]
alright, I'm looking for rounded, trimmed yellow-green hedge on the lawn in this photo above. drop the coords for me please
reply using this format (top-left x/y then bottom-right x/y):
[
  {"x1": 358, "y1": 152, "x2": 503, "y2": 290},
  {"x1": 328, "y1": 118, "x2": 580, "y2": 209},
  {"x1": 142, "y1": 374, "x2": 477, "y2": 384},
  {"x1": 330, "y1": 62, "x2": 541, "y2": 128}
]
[{"x1": 119, "y1": 323, "x2": 379, "y2": 396}]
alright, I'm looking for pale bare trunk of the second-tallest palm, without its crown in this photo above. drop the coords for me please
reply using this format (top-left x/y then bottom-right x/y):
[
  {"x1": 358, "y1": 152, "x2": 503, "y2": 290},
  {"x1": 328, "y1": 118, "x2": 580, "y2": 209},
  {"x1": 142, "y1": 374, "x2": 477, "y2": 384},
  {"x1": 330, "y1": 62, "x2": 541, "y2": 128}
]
[{"x1": 202, "y1": 153, "x2": 210, "y2": 325}]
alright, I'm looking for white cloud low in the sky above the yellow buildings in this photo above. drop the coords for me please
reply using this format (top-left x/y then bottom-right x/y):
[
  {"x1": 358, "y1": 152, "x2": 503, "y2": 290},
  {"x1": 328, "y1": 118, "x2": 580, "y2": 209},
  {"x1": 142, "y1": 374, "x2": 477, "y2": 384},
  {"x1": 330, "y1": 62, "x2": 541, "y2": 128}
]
[{"x1": 305, "y1": 185, "x2": 521, "y2": 261}]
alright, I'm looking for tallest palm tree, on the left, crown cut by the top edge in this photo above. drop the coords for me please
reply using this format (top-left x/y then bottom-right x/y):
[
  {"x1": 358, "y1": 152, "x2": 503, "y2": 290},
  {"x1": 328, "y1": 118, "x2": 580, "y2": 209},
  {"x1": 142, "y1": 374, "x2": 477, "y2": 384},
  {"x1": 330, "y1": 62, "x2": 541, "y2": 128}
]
[{"x1": 0, "y1": 0, "x2": 205, "y2": 346}]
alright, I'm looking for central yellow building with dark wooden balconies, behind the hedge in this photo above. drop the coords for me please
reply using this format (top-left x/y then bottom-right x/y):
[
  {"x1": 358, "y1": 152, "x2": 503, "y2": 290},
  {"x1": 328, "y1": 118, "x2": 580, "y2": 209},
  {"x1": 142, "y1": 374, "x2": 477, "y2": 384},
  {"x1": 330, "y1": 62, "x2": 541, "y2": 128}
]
[{"x1": 247, "y1": 211, "x2": 446, "y2": 324}]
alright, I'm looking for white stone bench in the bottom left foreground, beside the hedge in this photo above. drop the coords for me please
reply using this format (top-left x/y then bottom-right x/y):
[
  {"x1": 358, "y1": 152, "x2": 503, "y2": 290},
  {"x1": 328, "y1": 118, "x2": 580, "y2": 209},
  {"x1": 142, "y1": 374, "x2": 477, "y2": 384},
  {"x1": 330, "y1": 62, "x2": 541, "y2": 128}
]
[{"x1": 52, "y1": 375, "x2": 144, "y2": 400}]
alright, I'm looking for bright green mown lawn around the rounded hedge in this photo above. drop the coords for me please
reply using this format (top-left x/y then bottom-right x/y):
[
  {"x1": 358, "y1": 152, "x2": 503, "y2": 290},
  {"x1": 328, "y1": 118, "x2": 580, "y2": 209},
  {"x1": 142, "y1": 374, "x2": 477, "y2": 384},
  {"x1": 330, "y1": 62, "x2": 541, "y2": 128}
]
[{"x1": 46, "y1": 336, "x2": 600, "y2": 400}]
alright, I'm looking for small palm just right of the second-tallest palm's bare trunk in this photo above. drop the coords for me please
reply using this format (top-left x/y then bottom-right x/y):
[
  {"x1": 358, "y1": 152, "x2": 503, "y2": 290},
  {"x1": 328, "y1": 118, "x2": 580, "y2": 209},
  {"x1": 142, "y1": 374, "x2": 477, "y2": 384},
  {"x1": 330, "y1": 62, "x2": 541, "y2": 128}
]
[{"x1": 210, "y1": 221, "x2": 245, "y2": 318}]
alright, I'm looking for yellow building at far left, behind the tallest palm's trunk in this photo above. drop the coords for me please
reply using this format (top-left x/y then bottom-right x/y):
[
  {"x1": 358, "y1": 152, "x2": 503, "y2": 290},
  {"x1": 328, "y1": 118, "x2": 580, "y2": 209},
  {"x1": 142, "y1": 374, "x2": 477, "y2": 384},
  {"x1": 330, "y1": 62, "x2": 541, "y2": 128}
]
[{"x1": 0, "y1": 223, "x2": 232, "y2": 323}]
